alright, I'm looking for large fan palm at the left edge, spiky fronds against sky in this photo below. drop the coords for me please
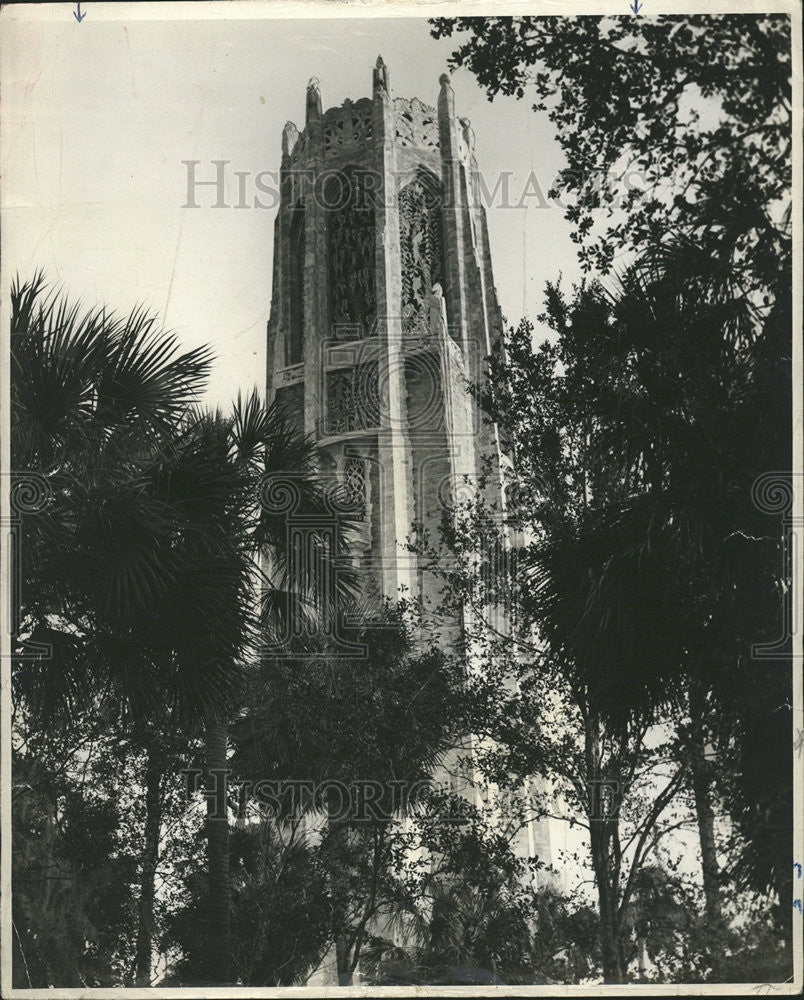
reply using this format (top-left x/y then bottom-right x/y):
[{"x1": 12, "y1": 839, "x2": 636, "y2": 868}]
[{"x1": 11, "y1": 273, "x2": 220, "y2": 984}]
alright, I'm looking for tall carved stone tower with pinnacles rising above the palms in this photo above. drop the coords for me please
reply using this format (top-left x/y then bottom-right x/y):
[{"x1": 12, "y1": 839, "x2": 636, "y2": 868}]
[{"x1": 267, "y1": 58, "x2": 549, "y2": 884}]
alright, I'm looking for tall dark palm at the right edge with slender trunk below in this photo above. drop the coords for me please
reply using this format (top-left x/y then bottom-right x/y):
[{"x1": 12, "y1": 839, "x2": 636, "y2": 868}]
[{"x1": 603, "y1": 232, "x2": 792, "y2": 926}]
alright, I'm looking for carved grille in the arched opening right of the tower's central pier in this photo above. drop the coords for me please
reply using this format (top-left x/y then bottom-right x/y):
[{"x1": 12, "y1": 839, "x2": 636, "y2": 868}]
[{"x1": 399, "y1": 174, "x2": 444, "y2": 336}]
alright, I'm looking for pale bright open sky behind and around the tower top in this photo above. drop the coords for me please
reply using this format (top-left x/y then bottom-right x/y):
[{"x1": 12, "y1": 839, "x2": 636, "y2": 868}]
[{"x1": 0, "y1": 4, "x2": 578, "y2": 403}]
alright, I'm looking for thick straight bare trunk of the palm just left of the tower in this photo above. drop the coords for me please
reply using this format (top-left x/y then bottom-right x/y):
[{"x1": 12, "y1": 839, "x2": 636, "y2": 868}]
[{"x1": 205, "y1": 721, "x2": 232, "y2": 986}]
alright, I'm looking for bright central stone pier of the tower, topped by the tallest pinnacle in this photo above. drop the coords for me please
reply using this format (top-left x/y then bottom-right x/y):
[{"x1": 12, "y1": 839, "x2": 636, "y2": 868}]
[{"x1": 372, "y1": 56, "x2": 415, "y2": 597}]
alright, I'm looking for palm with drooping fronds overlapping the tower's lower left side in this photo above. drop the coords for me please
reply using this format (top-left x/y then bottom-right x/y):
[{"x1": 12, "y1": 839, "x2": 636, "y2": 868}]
[{"x1": 177, "y1": 392, "x2": 360, "y2": 983}]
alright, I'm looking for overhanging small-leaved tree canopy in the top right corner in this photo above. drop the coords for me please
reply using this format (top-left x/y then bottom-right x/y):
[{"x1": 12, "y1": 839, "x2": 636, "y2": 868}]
[{"x1": 432, "y1": 14, "x2": 792, "y2": 282}]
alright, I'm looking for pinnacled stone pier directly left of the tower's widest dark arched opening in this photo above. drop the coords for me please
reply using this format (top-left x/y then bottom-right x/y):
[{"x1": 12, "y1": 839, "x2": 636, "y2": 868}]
[{"x1": 301, "y1": 77, "x2": 329, "y2": 435}]
